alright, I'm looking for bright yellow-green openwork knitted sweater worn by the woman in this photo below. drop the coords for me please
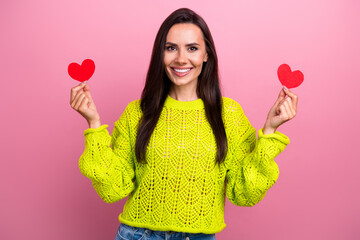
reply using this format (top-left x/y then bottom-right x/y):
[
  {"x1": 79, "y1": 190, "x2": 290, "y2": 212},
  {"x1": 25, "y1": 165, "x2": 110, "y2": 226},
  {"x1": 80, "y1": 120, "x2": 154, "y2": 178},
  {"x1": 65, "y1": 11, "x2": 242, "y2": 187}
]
[{"x1": 79, "y1": 96, "x2": 289, "y2": 234}]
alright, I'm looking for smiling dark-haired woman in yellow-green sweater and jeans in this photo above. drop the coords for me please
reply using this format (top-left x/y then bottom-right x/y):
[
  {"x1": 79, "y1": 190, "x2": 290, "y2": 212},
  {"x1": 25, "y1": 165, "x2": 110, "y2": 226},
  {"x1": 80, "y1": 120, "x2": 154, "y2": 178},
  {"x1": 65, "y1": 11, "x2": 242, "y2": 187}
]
[{"x1": 70, "y1": 8, "x2": 298, "y2": 239}]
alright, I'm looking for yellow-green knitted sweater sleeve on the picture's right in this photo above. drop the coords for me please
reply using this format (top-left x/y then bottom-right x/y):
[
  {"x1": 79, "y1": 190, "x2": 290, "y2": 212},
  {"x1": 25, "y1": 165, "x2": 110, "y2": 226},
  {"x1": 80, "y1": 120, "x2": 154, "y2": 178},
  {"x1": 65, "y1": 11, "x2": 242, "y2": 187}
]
[{"x1": 226, "y1": 101, "x2": 290, "y2": 206}]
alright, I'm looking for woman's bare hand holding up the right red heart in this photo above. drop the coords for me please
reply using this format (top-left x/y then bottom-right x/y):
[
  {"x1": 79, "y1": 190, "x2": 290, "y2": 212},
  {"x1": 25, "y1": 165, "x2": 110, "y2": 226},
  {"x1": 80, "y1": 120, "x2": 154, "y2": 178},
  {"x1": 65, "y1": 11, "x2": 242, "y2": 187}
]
[{"x1": 263, "y1": 88, "x2": 298, "y2": 134}]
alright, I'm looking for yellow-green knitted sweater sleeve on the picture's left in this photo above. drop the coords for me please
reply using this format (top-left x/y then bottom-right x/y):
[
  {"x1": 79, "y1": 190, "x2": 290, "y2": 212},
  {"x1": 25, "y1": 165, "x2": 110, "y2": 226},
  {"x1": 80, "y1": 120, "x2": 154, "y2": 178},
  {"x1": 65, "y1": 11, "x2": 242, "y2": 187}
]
[{"x1": 79, "y1": 102, "x2": 135, "y2": 203}]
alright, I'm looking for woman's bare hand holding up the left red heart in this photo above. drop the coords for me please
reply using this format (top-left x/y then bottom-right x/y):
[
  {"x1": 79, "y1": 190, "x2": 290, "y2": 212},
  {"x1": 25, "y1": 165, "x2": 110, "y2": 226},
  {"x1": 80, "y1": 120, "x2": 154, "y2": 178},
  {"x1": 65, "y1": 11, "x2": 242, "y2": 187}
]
[{"x1": 70, "y1": 82, "x2": 101, "y2": 128}]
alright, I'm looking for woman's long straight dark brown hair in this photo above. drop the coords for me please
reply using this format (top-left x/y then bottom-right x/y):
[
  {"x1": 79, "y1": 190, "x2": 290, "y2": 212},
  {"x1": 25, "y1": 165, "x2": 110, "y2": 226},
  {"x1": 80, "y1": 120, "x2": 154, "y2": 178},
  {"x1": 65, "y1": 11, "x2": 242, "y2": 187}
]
[{"x1": 135, "y1": 8, "x2": 227, "y2": 164}]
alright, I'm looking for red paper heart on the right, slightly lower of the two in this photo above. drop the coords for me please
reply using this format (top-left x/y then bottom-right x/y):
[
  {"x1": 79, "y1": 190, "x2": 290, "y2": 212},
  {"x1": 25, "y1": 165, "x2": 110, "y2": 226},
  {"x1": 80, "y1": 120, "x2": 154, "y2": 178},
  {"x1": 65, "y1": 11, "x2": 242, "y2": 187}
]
[{"x1": 278, "y1": 64, "x2": 304, "y2": 88}]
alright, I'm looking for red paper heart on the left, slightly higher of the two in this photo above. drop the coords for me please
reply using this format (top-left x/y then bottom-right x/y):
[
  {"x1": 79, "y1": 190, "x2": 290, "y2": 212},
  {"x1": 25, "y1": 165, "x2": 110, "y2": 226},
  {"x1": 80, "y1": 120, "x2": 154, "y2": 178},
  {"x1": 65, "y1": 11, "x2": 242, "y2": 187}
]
[{"x1": 68, "y1": 59, "x2": 95, "y2": 82}]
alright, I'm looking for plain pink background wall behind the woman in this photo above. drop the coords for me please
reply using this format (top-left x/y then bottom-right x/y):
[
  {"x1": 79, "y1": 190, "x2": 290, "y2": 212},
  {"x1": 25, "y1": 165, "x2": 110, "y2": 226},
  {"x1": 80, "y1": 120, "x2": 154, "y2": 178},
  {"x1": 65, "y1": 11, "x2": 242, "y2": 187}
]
[{"x1": 0, "y1": 0, "x2": 360, "y2": 240}]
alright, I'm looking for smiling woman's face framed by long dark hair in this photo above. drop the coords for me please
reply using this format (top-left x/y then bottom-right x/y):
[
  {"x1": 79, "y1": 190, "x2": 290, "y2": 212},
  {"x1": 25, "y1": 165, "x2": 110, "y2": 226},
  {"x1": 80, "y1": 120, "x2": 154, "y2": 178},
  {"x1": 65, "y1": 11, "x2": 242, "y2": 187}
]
[{"x1": 164, "y1": 23, "x2": 208, "y2": 90}]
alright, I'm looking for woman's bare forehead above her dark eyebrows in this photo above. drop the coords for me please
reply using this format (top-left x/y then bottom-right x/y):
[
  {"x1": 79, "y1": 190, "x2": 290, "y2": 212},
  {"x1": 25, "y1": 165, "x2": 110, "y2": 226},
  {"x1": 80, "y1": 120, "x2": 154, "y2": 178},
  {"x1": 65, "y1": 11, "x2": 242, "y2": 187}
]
[{"x1": 166, "y1": 23, "x2": 204, "y2": 44}]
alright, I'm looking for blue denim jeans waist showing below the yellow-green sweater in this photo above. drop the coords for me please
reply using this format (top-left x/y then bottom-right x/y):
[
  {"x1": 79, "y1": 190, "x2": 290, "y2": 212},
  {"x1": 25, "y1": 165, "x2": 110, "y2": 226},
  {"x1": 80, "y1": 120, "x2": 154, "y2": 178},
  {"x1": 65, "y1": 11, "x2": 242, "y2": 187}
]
[{"x1": 115, "y1": 223, "x2": 216, "y2": 240}]
